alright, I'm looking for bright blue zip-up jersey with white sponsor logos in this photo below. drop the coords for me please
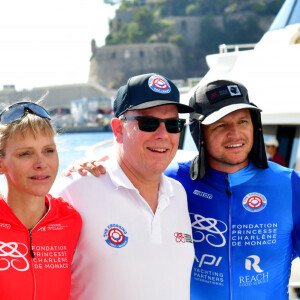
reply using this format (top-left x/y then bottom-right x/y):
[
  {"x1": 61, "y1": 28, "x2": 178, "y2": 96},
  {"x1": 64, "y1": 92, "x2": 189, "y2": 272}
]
[{"x1": 166, "y1": 162, "x2": 300, "y2": 300}]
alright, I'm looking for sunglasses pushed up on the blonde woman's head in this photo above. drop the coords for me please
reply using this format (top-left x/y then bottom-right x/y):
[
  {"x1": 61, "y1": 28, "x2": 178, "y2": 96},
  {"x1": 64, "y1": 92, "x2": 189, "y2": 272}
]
[{"x1": 0, "y1": 102, "x2": 51, "y2": 125}]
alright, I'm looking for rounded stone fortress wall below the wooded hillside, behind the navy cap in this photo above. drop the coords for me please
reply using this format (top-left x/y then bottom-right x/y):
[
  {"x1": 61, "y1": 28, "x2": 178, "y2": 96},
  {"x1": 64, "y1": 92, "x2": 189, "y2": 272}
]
[{"x1": 89, "y1": 41, "x2": 184, "y2": 88}]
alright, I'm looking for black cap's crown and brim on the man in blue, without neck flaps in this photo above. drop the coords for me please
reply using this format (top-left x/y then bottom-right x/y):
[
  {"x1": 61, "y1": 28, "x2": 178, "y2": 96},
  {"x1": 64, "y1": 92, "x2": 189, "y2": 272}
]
[{"x1": 189, "y1": 80, "x2": 261, "y2": 125}]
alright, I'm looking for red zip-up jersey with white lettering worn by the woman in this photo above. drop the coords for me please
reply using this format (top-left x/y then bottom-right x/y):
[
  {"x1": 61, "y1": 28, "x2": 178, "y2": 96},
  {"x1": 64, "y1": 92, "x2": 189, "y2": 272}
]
[{"x1": 0, "y1": 195, "x2": 82, "y2": 300}]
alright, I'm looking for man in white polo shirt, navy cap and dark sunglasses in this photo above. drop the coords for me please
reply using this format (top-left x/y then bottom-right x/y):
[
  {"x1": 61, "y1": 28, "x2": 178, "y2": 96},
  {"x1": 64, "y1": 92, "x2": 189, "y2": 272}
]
[{"x1": 54, "y1": 74, "x2": 194, "y2": 300}]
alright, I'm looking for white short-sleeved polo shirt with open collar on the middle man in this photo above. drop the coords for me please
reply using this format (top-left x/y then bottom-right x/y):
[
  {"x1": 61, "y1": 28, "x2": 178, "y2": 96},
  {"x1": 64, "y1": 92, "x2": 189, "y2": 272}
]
[{"x1": 57, "y1": 159, "x2": 194, "y2": 300}]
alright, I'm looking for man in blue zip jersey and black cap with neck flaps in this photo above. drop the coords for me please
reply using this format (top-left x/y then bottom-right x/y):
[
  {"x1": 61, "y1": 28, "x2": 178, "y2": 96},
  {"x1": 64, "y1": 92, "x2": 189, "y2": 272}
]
[{"x1": 166, "y1": 80, "x2": 300, "y2": 300}]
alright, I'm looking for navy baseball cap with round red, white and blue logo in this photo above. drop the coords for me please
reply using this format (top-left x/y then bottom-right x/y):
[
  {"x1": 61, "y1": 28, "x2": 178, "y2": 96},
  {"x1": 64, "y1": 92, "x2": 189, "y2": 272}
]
[{"x1": 114, "y1": 73, "x2": 194, "y2": 118}]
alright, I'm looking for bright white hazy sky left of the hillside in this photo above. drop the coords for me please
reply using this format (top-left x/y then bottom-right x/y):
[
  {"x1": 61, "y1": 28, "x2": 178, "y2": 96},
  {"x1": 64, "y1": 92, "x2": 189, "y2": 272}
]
[{"x1": 0, "y1": 0, "x2": 115, "y2": 90}]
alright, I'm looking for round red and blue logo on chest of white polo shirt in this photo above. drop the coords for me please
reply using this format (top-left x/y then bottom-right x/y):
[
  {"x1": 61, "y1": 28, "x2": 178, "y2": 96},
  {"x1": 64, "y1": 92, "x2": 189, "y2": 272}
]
[{"x1": 103, "y1": 224, "x2": 128, "y2": 248}]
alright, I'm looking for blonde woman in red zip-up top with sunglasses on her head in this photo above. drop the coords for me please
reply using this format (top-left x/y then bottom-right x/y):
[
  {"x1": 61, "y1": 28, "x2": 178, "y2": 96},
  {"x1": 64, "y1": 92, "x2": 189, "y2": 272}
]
[{"x1": 0, "y1": 102, "x2": 81, "y2": 300}]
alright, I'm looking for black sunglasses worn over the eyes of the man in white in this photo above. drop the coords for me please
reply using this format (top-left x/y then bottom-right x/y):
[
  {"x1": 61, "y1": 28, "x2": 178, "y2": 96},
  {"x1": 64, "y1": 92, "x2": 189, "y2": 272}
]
[{"x1": 120, "y1": 116, "x2": 185, "y2": 133}]
